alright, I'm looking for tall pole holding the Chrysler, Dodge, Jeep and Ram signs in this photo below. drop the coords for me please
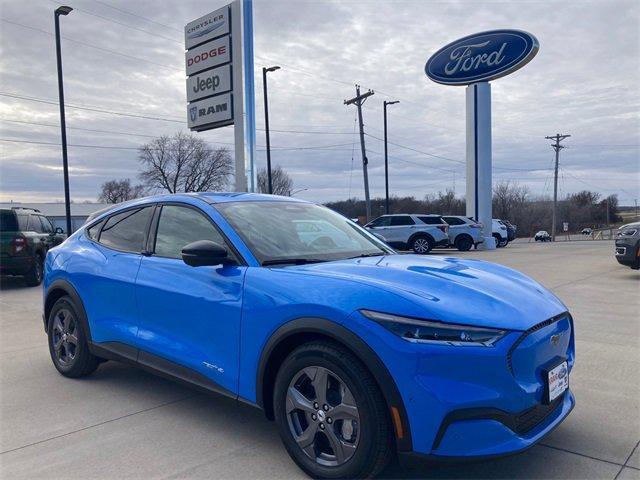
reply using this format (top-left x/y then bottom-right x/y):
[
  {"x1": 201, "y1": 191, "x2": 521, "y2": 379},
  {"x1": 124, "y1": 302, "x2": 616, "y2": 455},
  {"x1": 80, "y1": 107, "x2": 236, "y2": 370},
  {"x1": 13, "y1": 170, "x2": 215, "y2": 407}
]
[{"x1": 231, "y1": 0, "x2": 246, "y2": 192}]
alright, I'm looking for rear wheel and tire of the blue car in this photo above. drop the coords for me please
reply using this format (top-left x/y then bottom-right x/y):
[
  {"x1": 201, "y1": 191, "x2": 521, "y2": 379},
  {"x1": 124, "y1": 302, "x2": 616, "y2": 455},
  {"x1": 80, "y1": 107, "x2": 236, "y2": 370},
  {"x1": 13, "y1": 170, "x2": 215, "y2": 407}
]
[{"x1": 47, "y1": 296, "x2": 100, "y2": 378}]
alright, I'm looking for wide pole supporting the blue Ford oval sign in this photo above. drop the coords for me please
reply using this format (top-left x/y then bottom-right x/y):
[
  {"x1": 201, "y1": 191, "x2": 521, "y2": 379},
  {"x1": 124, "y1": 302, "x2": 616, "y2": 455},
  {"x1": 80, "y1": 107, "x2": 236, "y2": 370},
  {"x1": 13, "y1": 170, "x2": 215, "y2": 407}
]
[{"x1": 466, "y1": 82, "x2": 496, "y2": 250}]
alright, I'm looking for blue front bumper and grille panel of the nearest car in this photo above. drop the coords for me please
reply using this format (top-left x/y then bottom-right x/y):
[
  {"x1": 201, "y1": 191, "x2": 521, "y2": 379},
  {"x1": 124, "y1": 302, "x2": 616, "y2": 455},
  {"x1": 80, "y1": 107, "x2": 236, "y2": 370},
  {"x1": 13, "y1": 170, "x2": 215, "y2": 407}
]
[{"x1": 344, "y1": 313, "x2": 575, "y2": 460}]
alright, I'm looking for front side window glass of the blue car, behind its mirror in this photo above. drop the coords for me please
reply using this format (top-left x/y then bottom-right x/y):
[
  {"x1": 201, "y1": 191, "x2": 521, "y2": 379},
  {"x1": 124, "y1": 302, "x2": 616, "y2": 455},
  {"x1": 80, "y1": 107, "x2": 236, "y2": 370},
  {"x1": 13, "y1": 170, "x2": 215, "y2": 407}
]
[{"x1": 155, "y1": 205, "x2": 226, "y2": 258}]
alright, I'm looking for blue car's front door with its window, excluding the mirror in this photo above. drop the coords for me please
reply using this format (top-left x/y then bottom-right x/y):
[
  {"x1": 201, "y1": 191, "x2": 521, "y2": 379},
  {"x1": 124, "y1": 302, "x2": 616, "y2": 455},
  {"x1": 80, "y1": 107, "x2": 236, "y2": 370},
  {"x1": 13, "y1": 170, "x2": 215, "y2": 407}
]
[{"x1": 136, "y1": 203, "x2": 246, "y2": 393}]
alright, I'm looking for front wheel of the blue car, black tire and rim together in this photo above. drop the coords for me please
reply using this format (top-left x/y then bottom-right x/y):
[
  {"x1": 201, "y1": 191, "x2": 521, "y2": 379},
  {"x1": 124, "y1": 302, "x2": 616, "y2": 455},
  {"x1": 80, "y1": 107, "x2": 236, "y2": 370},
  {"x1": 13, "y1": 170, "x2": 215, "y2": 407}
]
[{"x1": 274, "y1": 342, "x2": 393, "y2": 479}]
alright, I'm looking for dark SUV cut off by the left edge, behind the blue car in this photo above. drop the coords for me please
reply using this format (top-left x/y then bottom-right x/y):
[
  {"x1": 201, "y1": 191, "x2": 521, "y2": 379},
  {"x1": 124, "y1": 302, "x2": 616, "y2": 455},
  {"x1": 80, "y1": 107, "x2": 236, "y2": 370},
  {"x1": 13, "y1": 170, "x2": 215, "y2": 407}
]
[{"x1": 0, "y1": 208, "x2": 65, "y2": 287}]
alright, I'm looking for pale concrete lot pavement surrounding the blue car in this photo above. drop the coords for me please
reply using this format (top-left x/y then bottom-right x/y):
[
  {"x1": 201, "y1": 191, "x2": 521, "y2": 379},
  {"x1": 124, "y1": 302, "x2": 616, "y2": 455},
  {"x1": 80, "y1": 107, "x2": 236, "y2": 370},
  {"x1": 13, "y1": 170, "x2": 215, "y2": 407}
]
[{"x1": 0, "y1": 241, "x2": 640, "y2": 479}]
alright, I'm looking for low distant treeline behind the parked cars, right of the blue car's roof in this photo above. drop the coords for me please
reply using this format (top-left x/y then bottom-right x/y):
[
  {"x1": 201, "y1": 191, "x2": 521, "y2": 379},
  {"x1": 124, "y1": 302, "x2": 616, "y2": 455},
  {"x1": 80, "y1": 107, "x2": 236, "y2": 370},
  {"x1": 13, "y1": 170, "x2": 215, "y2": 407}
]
[{"x1": 326, "y1": 182, "x2": 622, "y2": 236}]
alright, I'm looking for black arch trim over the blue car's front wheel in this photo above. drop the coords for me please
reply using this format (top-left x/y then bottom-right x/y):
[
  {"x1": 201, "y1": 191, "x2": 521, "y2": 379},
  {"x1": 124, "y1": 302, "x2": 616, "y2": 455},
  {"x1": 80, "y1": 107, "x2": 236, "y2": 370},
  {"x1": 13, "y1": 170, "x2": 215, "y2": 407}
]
[{"x1": 256, "y1": 317, "x2": 413, "y2": 452}]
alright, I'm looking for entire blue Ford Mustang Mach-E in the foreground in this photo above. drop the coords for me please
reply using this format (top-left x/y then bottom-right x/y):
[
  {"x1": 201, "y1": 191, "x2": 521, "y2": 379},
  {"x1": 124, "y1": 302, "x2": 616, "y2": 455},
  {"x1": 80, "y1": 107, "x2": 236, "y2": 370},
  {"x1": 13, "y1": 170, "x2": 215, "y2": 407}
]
[{"x1": 44, "y1": 193, "x2": 574, "y2": 478}]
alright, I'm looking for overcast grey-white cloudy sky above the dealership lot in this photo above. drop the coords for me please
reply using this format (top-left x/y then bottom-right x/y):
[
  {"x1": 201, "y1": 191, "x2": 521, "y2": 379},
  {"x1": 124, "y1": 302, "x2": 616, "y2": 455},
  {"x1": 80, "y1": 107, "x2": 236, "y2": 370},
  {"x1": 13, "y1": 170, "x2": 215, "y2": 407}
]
[{"x1": 0, "y1": 0, "x2": 640, "y2": 205}]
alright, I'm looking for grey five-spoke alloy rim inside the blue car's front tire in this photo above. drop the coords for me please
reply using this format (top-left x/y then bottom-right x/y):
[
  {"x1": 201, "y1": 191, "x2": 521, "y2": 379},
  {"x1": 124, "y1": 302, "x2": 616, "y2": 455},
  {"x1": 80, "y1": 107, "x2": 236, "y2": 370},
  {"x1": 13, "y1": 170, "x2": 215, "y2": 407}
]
[{"x1": 286, "y1": 366, "x2": 360, "y2": 467}]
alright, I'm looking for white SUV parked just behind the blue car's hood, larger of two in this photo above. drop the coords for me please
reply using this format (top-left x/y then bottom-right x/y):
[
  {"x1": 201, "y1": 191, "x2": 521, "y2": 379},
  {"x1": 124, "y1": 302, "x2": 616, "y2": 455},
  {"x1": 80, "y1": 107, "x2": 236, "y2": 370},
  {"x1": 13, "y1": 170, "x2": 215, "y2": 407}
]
[{"x1": 365, "y1": 214, "x2": 449, "y2": 254}]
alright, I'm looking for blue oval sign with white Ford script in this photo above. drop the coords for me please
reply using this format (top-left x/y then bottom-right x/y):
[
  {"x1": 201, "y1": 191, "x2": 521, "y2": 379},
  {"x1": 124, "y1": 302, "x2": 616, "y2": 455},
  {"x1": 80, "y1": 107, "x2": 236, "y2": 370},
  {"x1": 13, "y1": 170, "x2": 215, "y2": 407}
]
[{"x1": 425, "y1": 30, "x2": 540, "y2": 85}]
